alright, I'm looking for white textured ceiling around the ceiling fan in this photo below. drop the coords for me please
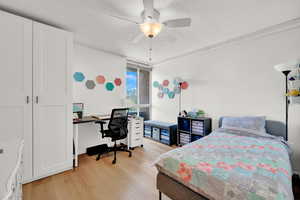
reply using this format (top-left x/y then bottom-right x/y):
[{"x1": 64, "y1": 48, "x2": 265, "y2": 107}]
[{"x1": 0, "y1": 0, "x2": 300, "y2": 62}]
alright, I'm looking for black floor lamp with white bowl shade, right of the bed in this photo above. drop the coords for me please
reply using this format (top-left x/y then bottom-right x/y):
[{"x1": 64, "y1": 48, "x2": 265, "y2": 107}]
[{"x1": 274, "y1": 63, "x2": 298, "y2": 140}]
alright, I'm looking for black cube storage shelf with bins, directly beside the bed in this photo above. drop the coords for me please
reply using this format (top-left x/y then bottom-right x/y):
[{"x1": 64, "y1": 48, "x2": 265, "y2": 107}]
[{"x1": 177, "y1": 117, "x2": 212, "y2": 146}]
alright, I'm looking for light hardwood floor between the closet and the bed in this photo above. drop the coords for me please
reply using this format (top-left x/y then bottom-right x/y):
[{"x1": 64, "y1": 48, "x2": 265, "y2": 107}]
[{"x1": 23, "y1": 139, "x2": 172, "y2": 200}]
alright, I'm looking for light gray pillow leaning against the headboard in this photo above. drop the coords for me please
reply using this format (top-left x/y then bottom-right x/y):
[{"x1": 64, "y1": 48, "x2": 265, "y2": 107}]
[{"x1": 222, "y1": 116, "x2": 266, "y2": 133}]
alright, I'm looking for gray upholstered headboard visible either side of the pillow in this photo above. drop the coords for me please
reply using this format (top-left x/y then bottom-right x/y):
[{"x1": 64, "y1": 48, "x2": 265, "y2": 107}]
[{"x1": 219, "y1": 117, "x2": 287, "y2": 140}]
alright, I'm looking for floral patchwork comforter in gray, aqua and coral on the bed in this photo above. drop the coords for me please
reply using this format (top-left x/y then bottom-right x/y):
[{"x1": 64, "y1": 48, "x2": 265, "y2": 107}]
[{"x1": 155, "y1": 129, "x2": 294, "y2": 200}]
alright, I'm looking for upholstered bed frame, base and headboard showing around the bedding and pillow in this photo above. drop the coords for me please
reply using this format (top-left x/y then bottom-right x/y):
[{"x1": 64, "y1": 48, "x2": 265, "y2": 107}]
[{"x1": 156, "y1": 118, "x2": 287, "y2": 200}]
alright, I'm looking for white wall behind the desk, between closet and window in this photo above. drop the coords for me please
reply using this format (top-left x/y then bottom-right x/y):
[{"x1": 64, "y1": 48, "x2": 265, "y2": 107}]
[{"x1": 73, "y1": 45, "x2": 126, "y2": 153}]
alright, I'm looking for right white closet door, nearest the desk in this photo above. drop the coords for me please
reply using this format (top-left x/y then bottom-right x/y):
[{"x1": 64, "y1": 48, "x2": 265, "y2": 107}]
[{"x1": 33, "y1": 22, "x2": 73, "y2": 178}]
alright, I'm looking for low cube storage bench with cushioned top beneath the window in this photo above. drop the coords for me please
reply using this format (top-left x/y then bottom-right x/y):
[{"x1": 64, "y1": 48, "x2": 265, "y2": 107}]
[{"x1": 144, "y1": 120, "x2": 177, "y2": 145}]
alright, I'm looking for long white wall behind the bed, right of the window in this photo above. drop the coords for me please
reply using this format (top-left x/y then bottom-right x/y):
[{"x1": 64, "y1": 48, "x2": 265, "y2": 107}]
[{"x1": 152, "y1": 29, "x2": 300, "y2": 171}]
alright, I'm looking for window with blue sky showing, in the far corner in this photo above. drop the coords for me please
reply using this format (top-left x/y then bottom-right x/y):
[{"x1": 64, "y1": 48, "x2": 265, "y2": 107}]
[{"x1": 126, "y1": 63, "x2": 151, "y2": 120}]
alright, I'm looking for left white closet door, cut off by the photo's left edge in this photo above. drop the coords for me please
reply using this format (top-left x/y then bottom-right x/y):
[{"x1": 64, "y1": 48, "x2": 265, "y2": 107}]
[{"x1": 0, "y1": 11, "x2": 32, "y2": 183}]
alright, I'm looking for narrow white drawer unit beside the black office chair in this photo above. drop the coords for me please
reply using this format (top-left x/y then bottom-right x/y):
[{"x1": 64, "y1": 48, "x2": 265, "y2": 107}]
[{"x1": 127, "y1": 117, "x2": 144, "y2": 149}]
